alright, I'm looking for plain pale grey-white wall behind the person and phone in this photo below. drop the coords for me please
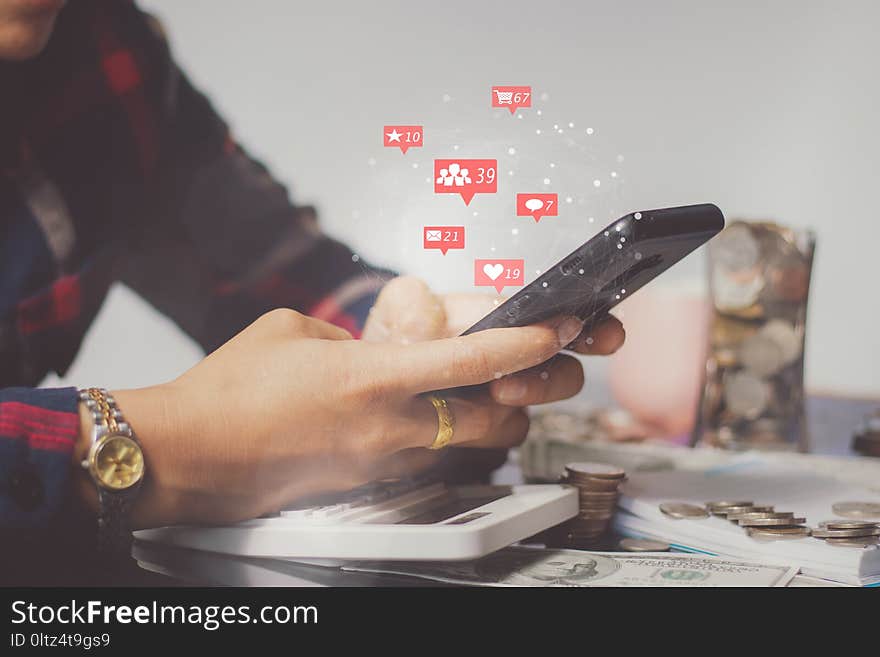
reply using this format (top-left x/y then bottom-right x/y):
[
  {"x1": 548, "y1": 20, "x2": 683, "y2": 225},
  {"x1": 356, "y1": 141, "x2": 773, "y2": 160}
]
[{"x1": 51, "y1": 0, "x2": 880, "y2": 396}]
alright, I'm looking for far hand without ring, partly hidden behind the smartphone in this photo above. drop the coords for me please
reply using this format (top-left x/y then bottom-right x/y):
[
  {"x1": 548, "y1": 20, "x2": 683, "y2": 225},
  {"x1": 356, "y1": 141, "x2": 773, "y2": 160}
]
[{"x1": 363, "y1": 276, "x2": 626, "y2": 406}]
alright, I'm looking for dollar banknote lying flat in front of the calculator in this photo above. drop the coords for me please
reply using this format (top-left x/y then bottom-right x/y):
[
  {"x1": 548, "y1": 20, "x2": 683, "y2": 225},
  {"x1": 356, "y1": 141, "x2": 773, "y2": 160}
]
[{"x1": 345, "y1": 547, "x2": 798, "y2": 587}]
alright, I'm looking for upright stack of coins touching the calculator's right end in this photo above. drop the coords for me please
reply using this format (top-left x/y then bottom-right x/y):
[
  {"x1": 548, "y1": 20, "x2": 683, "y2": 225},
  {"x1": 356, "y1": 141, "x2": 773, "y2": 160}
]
[{"x1": 547, "y1": 462, "x2": 626, "y2": 550}]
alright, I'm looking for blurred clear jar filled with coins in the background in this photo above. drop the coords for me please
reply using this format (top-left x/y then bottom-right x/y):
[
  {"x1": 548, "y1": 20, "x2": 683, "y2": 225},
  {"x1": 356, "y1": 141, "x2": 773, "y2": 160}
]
[{"x1": 694, "y1": 221, "x2": 814, "y2": 449}]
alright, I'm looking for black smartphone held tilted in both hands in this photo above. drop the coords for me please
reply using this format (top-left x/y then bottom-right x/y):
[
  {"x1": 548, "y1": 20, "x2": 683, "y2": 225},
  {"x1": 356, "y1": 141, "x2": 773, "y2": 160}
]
[{"x1": 462, "y1": 203, "x2": 724, "y2": 335}]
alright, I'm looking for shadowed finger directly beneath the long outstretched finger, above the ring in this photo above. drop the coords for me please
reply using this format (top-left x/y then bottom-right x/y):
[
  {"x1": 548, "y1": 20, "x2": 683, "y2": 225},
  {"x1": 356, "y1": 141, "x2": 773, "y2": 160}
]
[{"x1": 489, "y1": 354, "x2": 584, "y2": 406}]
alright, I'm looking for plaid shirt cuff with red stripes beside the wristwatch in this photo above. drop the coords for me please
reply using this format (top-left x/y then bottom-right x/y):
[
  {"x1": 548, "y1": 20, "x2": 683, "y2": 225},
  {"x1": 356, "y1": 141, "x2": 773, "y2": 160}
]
[{"x1": 0, "y1": 388, "x2": 80, "y2": 529}]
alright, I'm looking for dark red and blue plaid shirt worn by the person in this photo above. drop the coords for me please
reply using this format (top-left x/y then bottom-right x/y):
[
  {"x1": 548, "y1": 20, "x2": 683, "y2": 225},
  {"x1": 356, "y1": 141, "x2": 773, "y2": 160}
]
[{"x1": 0, "y1": 0, "x2": 389, "y2": 528}]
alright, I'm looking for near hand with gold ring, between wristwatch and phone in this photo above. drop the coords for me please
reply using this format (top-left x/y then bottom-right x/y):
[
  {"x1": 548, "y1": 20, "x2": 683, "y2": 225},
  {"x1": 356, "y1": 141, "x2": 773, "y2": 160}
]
[{"x1": 74, "y1": 309, "x2": 581, "y2": 527}]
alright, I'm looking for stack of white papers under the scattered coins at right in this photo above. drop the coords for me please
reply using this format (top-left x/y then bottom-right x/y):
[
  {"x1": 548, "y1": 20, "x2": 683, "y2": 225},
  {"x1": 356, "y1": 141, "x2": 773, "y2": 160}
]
[{"x1": 615, "y1": 458, "x2": 880, "y2": 586}]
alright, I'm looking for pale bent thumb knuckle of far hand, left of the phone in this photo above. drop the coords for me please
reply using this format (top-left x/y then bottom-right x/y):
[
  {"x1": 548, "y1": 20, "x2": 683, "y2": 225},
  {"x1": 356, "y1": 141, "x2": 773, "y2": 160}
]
[{"x1": 363, "y1": 276, "x2": 446, "y2": 344}]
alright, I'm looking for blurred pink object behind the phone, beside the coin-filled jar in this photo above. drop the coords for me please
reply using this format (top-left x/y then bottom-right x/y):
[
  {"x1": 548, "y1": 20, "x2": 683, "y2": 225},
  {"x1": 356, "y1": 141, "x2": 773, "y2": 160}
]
[{"x1": 609, "y1": 286, "x2": 710, "y2": 442}]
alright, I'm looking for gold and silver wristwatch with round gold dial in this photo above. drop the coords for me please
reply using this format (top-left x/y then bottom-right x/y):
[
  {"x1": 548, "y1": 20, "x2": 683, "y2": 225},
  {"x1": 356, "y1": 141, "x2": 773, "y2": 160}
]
[{"x1": 79, "y1": 388, "x2": 144, "y2": 557}]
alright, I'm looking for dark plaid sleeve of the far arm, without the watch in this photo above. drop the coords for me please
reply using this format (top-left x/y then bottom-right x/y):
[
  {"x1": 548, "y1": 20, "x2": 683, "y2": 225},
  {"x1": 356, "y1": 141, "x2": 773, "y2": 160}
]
[{"x1": 118, "y1": 16, "x2": 392, "y2": 351}]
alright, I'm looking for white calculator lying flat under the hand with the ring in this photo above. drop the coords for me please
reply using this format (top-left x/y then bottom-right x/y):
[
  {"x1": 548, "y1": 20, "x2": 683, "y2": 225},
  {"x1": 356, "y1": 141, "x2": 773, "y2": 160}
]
[{"x1": 135, "y1": 483, "x2": 578, "y2": 563}]
